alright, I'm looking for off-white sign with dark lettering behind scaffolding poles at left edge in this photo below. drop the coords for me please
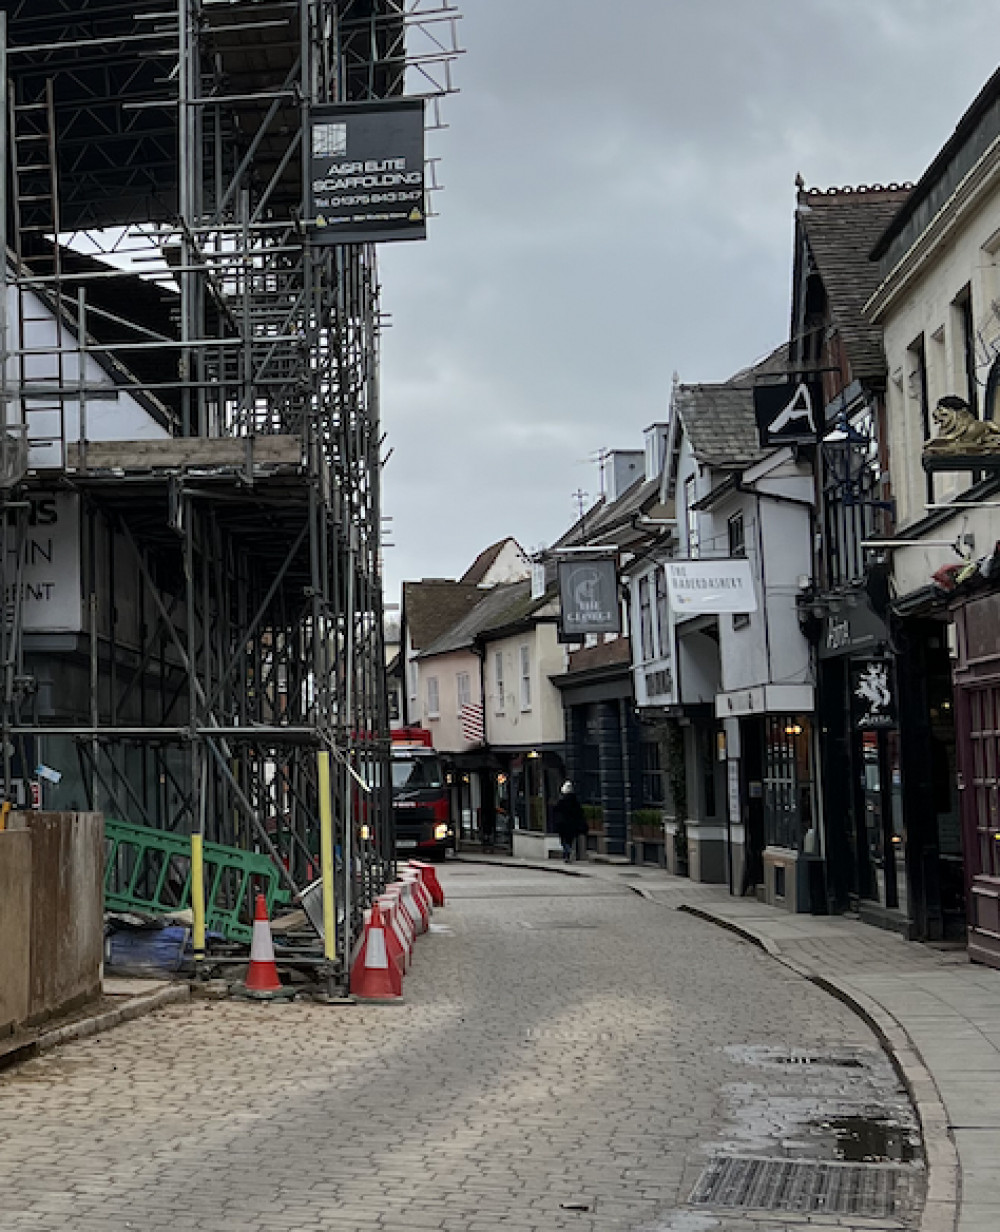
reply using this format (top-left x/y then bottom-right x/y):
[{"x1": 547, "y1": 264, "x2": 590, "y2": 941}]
[{"x1": 4, "y1": 493, "x2": 83, "y2": 633}]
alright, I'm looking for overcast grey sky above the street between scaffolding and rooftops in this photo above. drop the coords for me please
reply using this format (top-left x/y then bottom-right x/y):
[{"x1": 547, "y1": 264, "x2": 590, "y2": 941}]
[{"x1": 379, "y1": 0, "x2": 1000, "y2": 602}]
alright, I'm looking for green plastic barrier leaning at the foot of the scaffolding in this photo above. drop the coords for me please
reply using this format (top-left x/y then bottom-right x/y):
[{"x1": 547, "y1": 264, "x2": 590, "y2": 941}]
[{"x1": 105, "y1": 819, "x2": 291, "y2": 941}]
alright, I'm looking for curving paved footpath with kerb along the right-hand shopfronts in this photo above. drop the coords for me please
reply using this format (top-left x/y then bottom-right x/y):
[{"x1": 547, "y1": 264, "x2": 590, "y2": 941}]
[{"x1": 464, "y1": 855, "x2": 1000, "y2": 1232}]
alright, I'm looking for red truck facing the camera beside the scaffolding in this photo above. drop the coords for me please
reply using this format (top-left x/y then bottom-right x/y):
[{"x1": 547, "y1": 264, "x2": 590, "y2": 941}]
[{"x1": 392, "y1": 727, "x2": 454, "y2": 860}]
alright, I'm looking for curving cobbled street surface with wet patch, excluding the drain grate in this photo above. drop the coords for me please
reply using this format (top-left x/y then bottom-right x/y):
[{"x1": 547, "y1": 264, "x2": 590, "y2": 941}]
[{"x1": 0, "y1": 862, "x2": 922, "y2": 1232}]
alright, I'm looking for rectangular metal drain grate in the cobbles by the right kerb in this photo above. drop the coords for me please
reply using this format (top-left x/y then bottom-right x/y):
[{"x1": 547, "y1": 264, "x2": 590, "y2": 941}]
[{"x1": 690, "y1": 1156, "x2": 917, "y2": 1218}]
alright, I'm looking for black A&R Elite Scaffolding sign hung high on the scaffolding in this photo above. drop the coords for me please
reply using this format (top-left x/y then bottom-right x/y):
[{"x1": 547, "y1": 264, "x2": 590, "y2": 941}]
[{"x1": 307, "y1": 99, "x2": 427, "y2": 244}]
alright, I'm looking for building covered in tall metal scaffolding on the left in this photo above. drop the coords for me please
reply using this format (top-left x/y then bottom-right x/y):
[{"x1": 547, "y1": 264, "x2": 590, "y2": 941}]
[{"x1": 0, "y1": 0, "x2": 456, "y2": 980}]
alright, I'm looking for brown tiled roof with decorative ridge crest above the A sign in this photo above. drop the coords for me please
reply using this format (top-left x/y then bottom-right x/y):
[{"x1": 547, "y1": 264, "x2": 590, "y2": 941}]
[{"x1": 798, "y1": 186, "x2": 910, "y2": 381}]
